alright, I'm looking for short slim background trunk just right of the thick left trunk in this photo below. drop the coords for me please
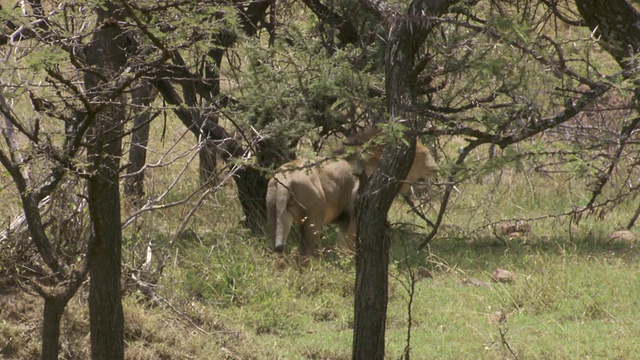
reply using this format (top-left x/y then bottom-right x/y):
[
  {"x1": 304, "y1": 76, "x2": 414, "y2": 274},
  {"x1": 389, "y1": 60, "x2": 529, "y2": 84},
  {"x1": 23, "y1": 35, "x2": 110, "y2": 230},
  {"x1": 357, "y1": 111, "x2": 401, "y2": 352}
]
[{"x1": 124, "y1": 81, "x2": 155, "y2": 201}]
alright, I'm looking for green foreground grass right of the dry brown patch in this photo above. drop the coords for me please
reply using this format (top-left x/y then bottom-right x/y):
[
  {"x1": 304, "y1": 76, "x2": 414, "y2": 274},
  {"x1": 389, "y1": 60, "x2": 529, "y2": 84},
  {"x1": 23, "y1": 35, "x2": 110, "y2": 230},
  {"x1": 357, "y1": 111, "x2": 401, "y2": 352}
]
[{"x1": 155, "y1": 225, "x2": 640, "y2": 359}]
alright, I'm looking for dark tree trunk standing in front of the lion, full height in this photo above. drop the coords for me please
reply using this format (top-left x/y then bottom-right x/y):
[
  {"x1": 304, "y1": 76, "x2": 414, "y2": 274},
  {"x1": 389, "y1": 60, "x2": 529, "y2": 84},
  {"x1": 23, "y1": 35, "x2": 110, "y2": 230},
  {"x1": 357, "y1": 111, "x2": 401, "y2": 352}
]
[{"x1": 353, "y1": 0, "x2": 453, "y2": 360}]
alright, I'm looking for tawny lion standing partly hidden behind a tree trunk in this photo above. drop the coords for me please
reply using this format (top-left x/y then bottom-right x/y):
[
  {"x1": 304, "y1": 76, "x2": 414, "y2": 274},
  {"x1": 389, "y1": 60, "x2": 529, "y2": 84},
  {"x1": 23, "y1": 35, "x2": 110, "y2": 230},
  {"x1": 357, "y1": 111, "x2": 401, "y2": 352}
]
[{"x1": 266, "y1": 131, "x2": 437, "y2": 257}]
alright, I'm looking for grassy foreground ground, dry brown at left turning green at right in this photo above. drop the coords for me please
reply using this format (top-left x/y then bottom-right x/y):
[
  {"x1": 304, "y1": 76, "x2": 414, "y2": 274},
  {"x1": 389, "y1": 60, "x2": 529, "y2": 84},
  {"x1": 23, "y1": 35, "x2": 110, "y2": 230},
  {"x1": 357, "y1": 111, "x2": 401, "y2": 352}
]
[{"x1": 0, "y1": 222, "x2": 640, "y2": 359}]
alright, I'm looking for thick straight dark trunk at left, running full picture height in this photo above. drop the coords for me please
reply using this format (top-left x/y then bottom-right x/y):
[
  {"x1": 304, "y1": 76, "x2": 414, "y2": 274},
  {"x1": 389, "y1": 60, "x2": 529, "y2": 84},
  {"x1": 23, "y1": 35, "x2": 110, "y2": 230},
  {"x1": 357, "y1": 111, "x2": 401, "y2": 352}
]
[{"x1": 85, "y1": 1, "x2": 128, "y2": 360}]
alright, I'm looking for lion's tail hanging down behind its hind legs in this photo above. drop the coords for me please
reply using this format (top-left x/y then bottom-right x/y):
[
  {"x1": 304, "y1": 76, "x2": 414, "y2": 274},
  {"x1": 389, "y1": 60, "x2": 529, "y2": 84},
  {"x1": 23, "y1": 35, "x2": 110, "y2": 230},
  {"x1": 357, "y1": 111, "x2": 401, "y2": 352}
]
[{"x1": 267, "y1": 177, "x2": 292, "y2": 252}]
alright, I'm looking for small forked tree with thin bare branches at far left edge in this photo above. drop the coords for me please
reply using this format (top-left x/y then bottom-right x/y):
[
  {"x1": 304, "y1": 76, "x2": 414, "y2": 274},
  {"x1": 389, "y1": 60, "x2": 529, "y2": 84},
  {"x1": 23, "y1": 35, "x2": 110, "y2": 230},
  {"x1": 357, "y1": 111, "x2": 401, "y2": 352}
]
[{"x1": 0, "y1": 95, "x2": 90, "y2": 359}]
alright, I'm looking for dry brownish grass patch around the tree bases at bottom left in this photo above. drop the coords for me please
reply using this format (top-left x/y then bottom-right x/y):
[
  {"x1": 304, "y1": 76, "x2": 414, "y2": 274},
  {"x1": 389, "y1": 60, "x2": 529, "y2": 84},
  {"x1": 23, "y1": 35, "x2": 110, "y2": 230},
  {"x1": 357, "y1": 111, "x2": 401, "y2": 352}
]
[{"x1": 0, "y1": 284, "x2": 256, "y2": 360}]
